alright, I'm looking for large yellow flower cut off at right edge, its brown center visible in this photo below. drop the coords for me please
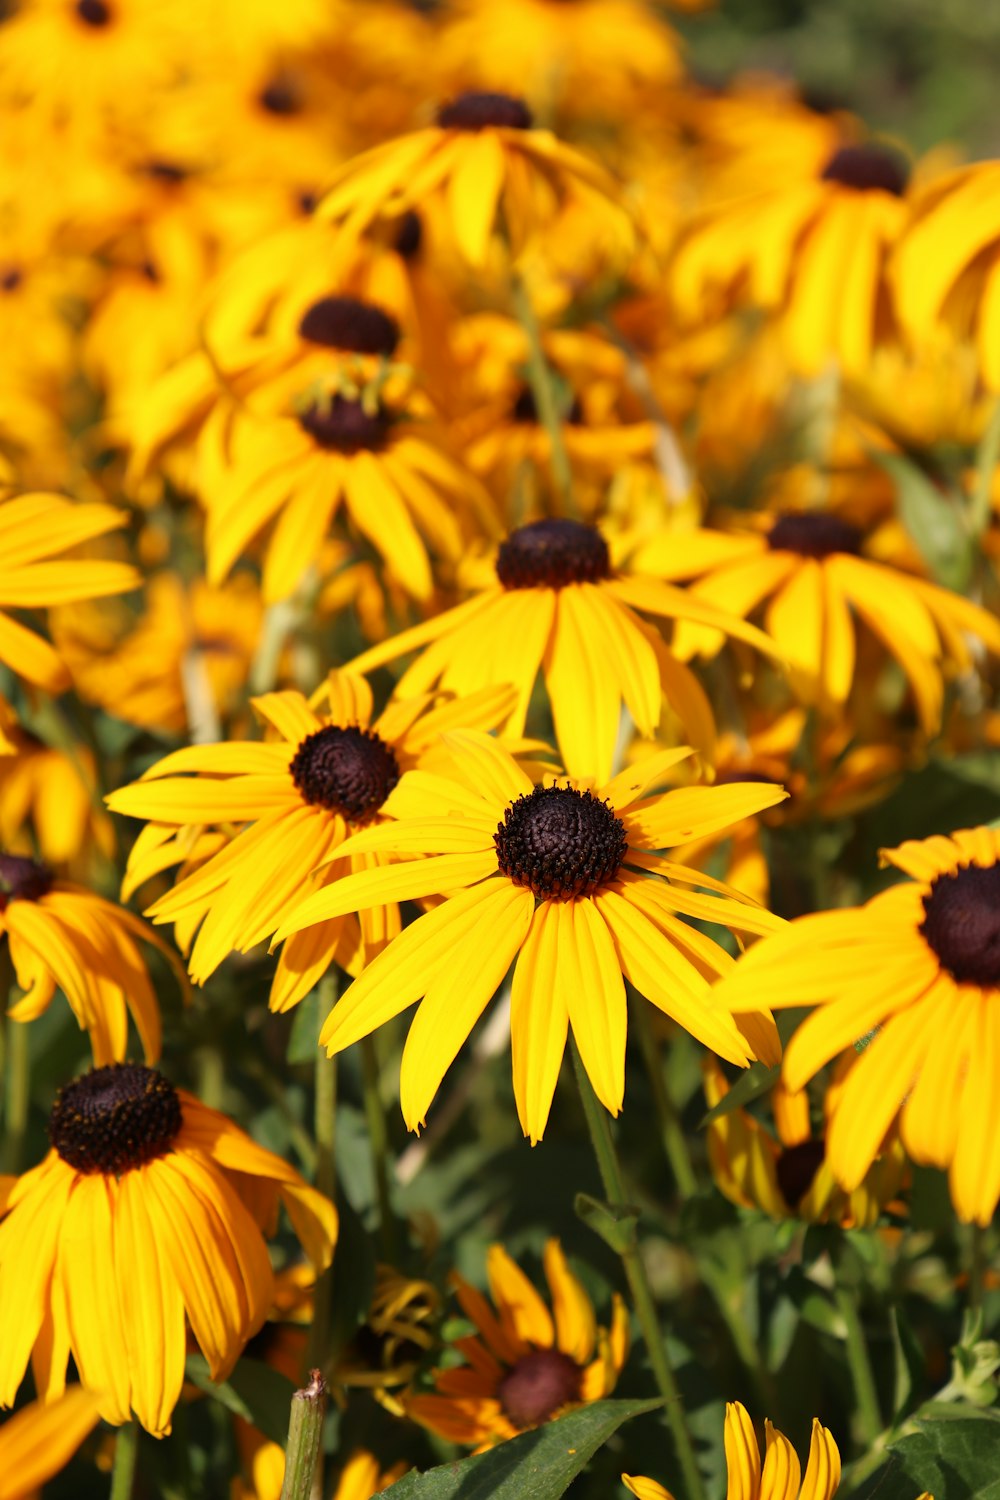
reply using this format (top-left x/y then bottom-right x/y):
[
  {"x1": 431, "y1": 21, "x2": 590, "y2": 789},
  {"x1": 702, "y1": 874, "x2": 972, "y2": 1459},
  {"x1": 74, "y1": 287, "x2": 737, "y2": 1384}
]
[{"x1": 715, "y1": 828, "x2": 1000, "y2": 1224}]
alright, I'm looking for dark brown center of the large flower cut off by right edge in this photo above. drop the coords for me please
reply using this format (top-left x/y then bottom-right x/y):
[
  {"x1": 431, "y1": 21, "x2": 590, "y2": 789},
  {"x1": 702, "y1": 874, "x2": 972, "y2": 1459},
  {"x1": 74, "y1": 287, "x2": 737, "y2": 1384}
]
[{"x1": 921, "y1": 864, "x2": 1000, "y2": 986}]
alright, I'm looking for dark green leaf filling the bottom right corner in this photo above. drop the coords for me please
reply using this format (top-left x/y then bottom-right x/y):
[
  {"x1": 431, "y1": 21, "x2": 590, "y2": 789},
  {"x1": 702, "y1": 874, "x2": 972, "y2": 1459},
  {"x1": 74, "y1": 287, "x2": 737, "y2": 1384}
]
[{"x1": 858, "y1": 1409, "x2": 1000, "y2": 1500}]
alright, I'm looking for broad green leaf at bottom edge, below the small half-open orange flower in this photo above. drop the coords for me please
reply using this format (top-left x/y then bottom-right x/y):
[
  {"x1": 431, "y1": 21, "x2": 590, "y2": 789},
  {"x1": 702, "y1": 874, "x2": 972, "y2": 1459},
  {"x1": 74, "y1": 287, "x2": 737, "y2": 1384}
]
[{"x1": 374, "y1": 1401, "x2": 656, "y2": 1500}]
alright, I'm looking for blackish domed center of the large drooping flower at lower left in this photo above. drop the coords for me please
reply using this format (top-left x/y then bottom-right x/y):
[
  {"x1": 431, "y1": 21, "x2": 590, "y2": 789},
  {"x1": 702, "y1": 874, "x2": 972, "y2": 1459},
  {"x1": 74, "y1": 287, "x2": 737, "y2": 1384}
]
[{"x1": 48, "y1": 1062, "x2": 183, "y2": 1173}]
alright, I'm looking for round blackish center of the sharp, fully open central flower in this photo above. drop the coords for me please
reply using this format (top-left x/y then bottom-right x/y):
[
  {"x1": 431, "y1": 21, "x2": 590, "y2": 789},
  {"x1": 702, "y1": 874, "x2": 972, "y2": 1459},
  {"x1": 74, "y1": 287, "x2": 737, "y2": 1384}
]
[{"x1": 493, "y1": 786, "x2": 628, "y2": 902}]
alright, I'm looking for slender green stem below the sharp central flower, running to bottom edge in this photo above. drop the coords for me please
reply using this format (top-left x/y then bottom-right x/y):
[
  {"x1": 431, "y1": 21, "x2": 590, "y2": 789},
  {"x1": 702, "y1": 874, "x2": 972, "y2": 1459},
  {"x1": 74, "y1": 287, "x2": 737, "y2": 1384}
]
[{"x1": 573, "y1": 1043, "x2": 705, "y2": 1500}]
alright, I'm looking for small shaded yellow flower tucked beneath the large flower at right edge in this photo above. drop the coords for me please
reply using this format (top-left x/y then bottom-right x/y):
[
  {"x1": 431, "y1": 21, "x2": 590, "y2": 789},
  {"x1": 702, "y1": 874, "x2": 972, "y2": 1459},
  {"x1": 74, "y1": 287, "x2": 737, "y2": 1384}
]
[{"x1": 702, "y1": 1049, "x2": 907, "y2": 1229}]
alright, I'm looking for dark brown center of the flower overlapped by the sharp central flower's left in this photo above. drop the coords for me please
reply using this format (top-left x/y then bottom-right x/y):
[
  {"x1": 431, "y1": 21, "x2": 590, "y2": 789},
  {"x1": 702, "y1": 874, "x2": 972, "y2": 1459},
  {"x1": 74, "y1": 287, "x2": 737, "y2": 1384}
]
[{"x1": 289, "y1": 725, "x2": 399, "y2": 824}]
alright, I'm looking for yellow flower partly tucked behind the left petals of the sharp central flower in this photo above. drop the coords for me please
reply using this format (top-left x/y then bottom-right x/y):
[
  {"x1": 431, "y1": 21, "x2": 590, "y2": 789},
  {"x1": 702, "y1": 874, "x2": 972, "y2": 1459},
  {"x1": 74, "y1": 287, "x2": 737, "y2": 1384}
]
[{"x1": 108, "y1": 672, "x2": 521, "y2": 1011}]
